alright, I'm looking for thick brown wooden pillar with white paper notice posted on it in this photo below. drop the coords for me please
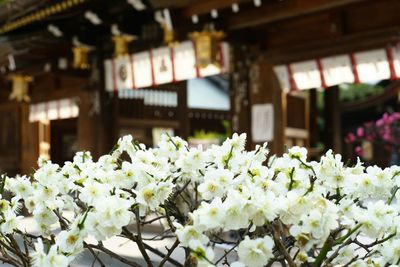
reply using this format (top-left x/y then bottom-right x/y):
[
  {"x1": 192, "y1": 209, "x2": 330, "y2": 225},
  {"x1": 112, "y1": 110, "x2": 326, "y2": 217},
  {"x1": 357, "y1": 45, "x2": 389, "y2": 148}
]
[{"x1": 231, "y1": 46, "x2": 286, "y2": 155}]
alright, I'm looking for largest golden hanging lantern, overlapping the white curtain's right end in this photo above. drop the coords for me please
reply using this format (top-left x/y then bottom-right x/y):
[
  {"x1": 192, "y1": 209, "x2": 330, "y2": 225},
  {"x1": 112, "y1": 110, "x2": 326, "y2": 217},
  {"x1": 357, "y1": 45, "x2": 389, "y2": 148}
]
[{"x1": 189, "y1": 27, "x2": 225, "y2": 68}]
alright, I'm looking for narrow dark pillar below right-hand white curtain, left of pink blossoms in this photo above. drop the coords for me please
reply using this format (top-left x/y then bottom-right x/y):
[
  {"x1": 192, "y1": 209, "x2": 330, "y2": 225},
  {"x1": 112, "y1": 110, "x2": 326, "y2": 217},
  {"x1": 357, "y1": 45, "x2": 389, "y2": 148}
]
[{"x1": 324, "y1": 86, "x2": 342, "y2": 153}]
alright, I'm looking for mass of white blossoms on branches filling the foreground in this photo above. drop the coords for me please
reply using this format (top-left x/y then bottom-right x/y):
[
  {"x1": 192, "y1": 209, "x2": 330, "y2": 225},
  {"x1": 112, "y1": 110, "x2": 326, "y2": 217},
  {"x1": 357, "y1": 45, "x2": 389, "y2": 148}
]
[{"x1": 0, "y1": 134, "x2": 400, "y2": 267}]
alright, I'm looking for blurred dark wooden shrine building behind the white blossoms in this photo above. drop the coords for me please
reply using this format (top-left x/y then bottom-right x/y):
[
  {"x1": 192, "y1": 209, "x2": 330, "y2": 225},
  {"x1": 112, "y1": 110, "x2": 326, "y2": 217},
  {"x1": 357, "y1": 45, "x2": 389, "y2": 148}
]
[{"x1": 0, "y1": 0, "x2": 400, "y2": 174}]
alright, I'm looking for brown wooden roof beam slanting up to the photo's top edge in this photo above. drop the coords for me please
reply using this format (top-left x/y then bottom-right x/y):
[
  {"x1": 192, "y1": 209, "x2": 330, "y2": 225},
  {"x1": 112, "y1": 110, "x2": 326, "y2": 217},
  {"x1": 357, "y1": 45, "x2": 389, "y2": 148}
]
[{"x1": 226, "y1": 0, "x2": 368, "y2": 30}]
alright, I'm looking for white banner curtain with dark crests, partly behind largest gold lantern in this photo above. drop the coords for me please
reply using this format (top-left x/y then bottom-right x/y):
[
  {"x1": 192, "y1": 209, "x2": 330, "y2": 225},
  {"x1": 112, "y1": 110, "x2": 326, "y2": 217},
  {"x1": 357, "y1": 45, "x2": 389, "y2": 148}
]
[{"x1": 104, "y1": 41, "x2": 230, "y2": 92}]
